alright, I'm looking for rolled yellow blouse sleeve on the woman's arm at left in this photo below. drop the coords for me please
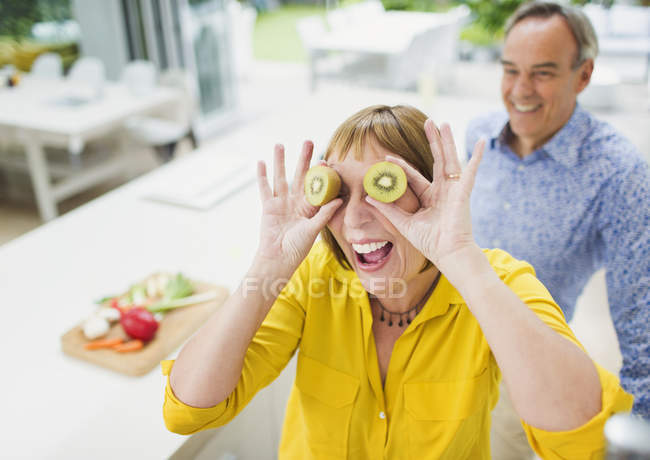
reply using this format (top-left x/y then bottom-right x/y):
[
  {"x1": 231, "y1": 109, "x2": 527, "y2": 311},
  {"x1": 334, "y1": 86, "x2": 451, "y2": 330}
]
[{"x1": 161, "y1": 260, "x2": 308, "y2": 434}]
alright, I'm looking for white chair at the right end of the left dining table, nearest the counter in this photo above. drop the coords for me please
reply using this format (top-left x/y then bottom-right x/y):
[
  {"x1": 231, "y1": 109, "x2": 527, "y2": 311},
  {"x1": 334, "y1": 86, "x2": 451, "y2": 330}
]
[{"x1": 125, "y1": 69, "x2": 198, "y2": 162}]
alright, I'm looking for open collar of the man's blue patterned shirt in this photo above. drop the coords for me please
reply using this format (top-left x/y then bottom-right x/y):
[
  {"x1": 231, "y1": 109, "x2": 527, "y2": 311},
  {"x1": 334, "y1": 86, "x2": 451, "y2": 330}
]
[{"x1": 490, "y1": 103, "x2": 591, "y2": 167}]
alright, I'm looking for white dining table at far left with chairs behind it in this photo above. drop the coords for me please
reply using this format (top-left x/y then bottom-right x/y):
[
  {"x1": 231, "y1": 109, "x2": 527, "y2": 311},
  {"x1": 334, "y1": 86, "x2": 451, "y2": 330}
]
[{"x1": 0, "y1": 77, "x2": 180, "y2": 221}]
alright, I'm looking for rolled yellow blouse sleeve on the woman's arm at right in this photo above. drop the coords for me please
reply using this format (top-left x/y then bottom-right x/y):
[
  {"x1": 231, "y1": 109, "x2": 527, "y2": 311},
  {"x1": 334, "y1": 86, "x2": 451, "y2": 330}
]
[{"x1": 496, "y1": 255, "x2": 634, "y2": 459}]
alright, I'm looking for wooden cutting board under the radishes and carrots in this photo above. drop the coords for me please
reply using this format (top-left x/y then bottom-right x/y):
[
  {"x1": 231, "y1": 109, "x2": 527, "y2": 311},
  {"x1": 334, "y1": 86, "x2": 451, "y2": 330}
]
[{"x1": 61, "y1": 281, "x2": 229, "y2": 376}]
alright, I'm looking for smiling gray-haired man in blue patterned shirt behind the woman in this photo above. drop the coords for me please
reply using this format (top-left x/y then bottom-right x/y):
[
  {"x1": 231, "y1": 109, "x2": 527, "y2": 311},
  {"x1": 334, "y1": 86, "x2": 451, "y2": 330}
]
[{"x1": 466, "y1": 2, "x2": 650, "y2": 459}]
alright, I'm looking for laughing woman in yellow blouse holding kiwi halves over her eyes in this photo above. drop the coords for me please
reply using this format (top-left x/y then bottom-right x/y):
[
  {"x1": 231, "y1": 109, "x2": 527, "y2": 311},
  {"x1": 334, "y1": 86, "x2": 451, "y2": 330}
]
[{"x1": 163, "y1": 106, "x2": 632, "y2": 460}]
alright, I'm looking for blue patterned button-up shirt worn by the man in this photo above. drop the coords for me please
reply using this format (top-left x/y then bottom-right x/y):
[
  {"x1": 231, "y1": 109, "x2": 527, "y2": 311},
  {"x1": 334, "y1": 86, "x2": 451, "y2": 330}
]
[{"x1": 466, "y1": 105, "x2": 650, "y2": 419}]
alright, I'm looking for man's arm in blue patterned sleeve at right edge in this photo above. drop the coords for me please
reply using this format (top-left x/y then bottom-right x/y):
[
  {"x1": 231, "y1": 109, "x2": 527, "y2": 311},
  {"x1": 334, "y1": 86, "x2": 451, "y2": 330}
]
[{"x1": 599, "y1": 160, "x2": 650, "y2": 420}]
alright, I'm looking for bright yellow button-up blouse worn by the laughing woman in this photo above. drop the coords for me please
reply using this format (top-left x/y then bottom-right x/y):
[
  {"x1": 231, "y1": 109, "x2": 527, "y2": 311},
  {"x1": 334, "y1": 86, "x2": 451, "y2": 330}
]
[{"x1": 162, "y1": 243, "x2": 633, "y2": 460}]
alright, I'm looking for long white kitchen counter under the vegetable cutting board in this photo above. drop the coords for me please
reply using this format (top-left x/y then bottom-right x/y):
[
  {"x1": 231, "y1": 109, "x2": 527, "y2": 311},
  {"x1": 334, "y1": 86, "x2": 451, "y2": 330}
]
[{"x1": 0, "y1": 88, "x2": 502, "y2": 460}]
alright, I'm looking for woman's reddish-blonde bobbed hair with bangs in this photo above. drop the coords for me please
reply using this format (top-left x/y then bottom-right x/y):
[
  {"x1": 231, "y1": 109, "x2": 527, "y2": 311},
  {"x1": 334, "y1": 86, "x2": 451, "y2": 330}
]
[{"x1": 321, "y1": 105, "x2": 433, "y2": 272}]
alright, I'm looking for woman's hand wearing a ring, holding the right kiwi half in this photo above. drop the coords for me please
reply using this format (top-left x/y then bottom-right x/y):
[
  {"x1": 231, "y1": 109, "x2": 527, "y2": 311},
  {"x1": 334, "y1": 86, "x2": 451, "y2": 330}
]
[{"x1": 366, "y1": 120, "x2": 485, "y2": 273}]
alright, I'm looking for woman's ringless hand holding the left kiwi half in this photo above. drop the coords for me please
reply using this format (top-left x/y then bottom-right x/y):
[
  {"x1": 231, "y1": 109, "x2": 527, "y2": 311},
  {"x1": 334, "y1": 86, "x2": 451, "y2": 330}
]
[{"x1": 257, "y1": 141, "x2": 343, "y2": 277}]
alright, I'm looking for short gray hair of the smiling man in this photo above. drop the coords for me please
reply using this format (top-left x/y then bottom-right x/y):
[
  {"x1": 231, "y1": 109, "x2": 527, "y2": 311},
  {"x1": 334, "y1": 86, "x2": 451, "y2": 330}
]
[{"x1": 505, "y1": 1, "x2": 598, "y2": 68}]
